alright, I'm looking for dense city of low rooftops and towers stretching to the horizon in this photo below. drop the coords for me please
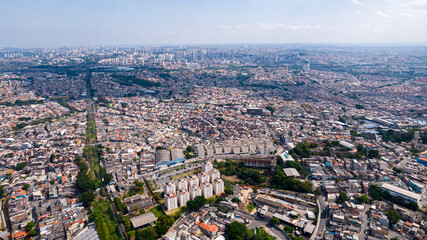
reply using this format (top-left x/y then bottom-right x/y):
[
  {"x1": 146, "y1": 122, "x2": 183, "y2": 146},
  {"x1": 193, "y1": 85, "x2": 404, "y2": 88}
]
[{"x1": 0, "y1": 45, "x2": 427, "y2": 240}]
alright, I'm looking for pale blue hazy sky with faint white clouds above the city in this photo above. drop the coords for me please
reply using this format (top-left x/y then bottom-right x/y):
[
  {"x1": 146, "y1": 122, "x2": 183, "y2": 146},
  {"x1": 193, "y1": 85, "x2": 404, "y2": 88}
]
[{"x1": 0, "y1": 0, "x2": 427, "y2": 47}]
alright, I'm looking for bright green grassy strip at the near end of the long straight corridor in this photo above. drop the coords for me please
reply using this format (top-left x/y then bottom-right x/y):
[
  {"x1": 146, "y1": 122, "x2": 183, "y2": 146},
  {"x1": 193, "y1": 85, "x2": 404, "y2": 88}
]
[{"x1": 90, "y1": 199, "x2": 121, "y2": 240}]
